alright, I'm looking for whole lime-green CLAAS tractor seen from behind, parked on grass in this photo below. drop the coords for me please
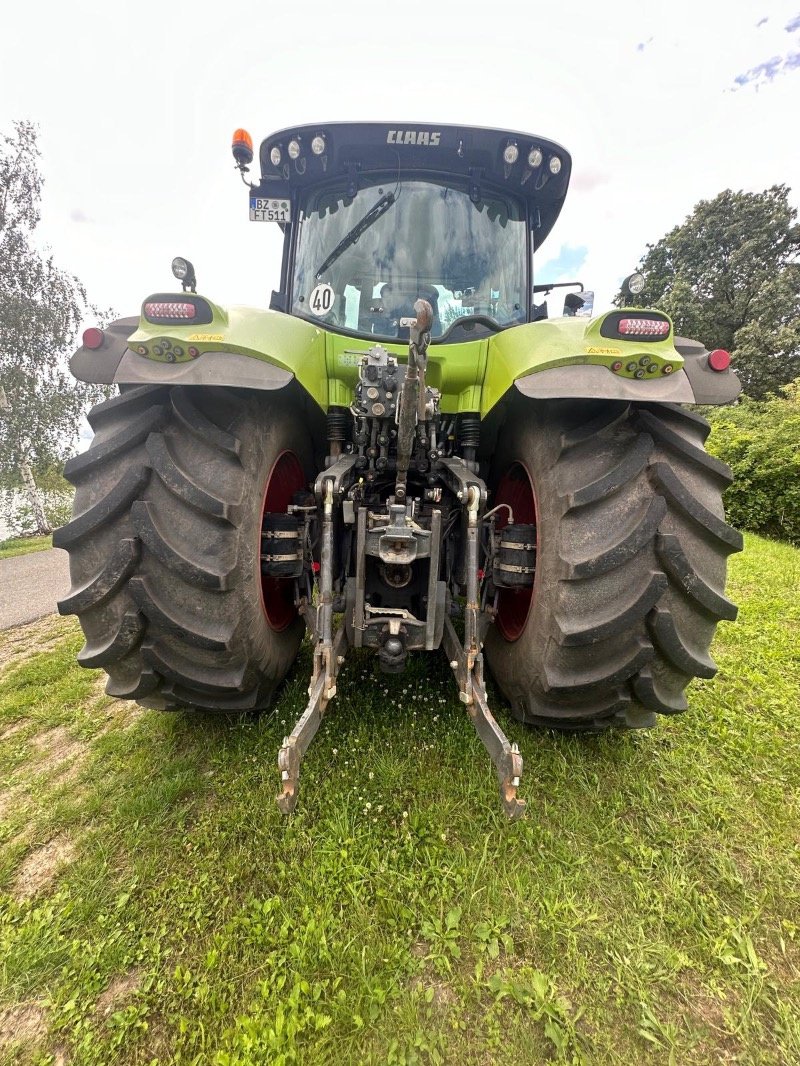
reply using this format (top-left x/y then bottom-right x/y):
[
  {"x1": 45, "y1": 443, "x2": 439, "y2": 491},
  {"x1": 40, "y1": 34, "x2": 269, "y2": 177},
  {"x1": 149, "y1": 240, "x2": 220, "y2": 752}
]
[{"x1": 54, "y1": 123, "x2": 741, "y2": 818}]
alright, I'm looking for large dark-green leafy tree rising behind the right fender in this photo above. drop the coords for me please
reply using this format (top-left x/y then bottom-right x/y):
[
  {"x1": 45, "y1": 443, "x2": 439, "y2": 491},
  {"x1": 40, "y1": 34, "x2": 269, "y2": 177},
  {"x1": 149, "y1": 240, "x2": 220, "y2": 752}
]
[{"x1": 617, "y1": 185, "x2": 800, "y2": 399}]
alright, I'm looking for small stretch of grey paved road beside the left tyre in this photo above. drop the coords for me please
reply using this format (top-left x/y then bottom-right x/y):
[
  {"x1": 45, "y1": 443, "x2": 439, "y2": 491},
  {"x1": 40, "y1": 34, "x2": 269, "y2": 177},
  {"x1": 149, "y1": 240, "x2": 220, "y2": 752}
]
[{"x1": 0, "y1": 548, "x2": 69, "y2": 629}]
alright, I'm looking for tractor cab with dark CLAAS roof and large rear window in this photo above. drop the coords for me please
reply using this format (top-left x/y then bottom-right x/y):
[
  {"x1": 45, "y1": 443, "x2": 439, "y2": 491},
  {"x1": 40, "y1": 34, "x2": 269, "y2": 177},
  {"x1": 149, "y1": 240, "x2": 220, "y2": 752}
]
[{"x1": 235, "y1": 123, "x2": 571, "y2": 343}]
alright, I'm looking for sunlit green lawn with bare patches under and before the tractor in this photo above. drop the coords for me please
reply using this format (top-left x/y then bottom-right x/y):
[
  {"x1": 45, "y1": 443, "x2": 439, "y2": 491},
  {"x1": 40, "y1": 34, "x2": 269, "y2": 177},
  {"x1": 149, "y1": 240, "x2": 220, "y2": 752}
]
[{"x1": 0, "y1": 537, "x2": 800, "y2": 1066}]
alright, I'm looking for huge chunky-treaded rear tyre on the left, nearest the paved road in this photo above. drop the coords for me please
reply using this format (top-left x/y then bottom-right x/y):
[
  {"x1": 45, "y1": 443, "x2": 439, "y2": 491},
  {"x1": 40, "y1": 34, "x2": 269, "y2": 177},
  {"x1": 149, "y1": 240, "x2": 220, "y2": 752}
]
[{"x1": 53, "y1": 386, "x2": 311, "y2": 711}]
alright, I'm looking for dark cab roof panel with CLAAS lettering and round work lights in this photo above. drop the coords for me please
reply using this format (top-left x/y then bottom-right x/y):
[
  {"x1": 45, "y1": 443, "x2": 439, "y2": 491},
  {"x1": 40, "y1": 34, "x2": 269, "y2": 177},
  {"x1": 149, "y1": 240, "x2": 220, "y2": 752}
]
[{"x1": 258, "y1": 123, "x2": 572, "y2": 247}]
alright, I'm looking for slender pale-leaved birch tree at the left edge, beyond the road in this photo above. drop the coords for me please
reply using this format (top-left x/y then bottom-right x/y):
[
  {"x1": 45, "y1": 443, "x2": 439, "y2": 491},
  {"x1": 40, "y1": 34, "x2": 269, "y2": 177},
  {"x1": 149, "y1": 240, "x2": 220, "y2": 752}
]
[{"x1": 0, "y1": 122, "x2": 108, "y2": 533}]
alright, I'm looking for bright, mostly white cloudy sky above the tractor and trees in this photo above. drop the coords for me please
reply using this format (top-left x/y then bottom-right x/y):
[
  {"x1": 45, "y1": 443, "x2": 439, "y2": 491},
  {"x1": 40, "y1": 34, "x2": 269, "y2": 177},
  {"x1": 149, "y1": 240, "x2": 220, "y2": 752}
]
[{"x1": 0, "y1": 0, "x2": 800, "y2": 316}]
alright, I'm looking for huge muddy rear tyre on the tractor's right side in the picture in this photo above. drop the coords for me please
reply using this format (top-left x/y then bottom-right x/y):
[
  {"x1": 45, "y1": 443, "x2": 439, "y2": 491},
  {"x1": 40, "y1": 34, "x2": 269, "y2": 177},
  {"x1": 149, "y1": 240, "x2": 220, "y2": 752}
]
[{"x1": 485, "y1": 401, "x2": 742, "y2": 729}]
